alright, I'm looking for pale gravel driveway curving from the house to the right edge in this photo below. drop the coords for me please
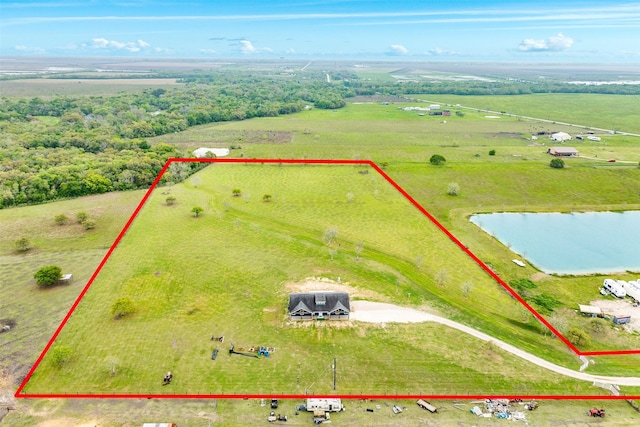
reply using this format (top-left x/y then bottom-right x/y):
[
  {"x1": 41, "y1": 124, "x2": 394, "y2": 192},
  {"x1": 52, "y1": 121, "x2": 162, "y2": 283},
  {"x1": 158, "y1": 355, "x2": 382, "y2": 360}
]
[{"x1": 349, "y1": 301, "x2": 640, "y2": 386}]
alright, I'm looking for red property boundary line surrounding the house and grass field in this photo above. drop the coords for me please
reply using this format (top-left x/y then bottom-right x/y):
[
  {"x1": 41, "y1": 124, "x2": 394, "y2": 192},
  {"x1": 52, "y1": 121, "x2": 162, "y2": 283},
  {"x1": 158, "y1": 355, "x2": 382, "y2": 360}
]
[{"x1": 14, "y1": 158, "x2": 640, "y2": 400}]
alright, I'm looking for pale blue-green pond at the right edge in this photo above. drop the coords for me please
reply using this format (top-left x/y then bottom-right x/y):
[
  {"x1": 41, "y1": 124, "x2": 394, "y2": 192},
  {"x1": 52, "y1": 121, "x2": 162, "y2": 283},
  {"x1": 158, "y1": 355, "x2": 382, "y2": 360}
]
[{"x1": 470, "y1": 211, "x2": 640, "y2": 275}]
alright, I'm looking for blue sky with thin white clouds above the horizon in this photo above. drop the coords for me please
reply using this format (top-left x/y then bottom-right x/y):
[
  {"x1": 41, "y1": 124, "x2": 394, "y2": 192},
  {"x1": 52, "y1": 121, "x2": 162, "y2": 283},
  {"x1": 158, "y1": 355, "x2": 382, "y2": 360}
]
[{"x1": 0, "y1": 0, "x2": 640, "y2": 63}]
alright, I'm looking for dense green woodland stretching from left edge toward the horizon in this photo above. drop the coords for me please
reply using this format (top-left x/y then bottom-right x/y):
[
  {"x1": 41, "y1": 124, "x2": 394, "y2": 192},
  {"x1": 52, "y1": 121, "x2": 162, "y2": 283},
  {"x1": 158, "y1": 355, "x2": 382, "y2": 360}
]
[{"x1": 0, "y1": 71, "x2": 640, "y2": 208}]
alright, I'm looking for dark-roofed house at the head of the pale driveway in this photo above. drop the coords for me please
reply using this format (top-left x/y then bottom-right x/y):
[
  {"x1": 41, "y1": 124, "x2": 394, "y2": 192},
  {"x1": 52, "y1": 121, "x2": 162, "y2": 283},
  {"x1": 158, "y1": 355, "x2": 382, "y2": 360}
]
[{"x1": 289, "y1": 291, "x2": 351, "y2": 320}]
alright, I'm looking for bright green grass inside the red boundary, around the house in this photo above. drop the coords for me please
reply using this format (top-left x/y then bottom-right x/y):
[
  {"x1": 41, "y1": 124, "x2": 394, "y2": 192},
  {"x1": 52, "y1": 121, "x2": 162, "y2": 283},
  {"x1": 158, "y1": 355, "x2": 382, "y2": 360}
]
[{"x1": 24, "y1": 164, "x2": 612, "y2": 395}]
